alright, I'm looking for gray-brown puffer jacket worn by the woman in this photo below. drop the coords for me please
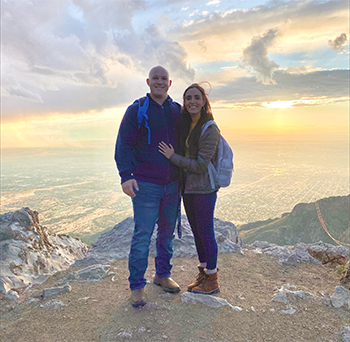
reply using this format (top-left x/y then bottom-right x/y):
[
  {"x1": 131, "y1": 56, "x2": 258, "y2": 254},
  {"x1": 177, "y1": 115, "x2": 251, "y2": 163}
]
[{"x1": 170, "y1": 125, "x2": 220, "y2": 194}]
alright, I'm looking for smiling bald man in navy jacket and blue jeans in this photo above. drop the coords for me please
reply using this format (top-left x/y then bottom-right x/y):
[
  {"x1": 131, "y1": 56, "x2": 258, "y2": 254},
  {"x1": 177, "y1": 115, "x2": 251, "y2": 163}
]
[{"x1": 115, "y1": 66, "x2": 181, "y2": 307}]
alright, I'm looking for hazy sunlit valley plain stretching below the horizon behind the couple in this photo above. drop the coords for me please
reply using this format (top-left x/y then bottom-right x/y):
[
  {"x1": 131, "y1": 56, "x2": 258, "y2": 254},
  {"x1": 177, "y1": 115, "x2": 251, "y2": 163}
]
[{"x1": 1, "y1": 141, "x2": 349, "y2": 242}]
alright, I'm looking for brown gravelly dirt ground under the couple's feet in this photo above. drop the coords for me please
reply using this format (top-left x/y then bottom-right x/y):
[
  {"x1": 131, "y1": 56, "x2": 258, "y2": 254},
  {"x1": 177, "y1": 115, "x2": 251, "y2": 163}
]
[{"x1": 0, "y1": 250, "x2": 350, "y2": 342}]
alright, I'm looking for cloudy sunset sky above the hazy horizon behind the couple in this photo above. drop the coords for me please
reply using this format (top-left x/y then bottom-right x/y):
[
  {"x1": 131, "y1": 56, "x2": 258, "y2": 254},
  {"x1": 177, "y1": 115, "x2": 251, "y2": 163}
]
[{"x1": 1, "y1": 0, "x2": 349, "y2": 148}]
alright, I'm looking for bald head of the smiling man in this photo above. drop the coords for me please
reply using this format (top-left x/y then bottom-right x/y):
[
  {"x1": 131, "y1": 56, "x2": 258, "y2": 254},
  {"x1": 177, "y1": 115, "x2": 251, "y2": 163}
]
[{"x1": 146, "y1": 66, "x2": 172, "y2": 104}]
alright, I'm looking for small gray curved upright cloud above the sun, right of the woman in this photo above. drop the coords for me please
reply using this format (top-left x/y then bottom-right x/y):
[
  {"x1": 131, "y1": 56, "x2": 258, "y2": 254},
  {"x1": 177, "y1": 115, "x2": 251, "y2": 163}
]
[{"x1": 242, "y1": 29, "x2": 279, "y2": 85}]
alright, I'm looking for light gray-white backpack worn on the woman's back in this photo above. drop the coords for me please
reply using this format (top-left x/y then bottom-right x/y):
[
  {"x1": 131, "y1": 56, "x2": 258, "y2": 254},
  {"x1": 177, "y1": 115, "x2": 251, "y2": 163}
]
[{"x1": 201, "y1": 120, "x2": 233, "y2": 189}]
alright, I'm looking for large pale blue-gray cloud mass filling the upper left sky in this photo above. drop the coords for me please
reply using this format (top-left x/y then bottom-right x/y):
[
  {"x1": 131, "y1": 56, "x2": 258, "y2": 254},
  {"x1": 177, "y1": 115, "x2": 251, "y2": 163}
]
[{"x1": 2, "y1": 0, "x2": 194, "y2": 118}]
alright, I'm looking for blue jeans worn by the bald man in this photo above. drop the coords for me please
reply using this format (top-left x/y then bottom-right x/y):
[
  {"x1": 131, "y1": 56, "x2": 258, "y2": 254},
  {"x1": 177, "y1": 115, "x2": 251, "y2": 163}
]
[{"x1": 129, "y1": 181, "x2": 179, "y2": 290}]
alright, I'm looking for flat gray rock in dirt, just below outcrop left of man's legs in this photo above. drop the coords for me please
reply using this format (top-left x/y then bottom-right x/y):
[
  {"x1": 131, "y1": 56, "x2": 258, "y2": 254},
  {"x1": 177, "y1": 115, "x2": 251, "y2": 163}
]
[{"x1": 56, "y1": 265, "x2": 110, "y2": 285}]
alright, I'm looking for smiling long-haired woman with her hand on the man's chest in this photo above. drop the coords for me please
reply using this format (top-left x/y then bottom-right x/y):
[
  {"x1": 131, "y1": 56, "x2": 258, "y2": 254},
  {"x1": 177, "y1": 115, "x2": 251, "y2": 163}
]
[{"x1": 159, "y1": 83, "x2": 220, "y2": 294}]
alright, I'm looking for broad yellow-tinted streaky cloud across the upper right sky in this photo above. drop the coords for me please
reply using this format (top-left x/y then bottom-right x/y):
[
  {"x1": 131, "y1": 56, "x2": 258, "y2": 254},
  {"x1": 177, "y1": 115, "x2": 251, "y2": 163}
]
[{"x1": 168, "y1": 0, "x2": 349, "y2": 64}]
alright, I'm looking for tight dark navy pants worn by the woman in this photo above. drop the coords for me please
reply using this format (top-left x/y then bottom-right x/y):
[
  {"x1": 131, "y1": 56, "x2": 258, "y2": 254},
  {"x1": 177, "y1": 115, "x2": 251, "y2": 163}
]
[{"x1": 183, "y1": 192, "x2": 218, "y2": 270}]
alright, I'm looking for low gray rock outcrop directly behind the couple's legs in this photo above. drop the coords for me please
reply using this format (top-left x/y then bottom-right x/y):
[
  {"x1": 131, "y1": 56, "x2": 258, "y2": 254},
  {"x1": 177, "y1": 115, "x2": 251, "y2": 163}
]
[{"x1": 74, "y1": 216, "x2": 242, "y2": 266}]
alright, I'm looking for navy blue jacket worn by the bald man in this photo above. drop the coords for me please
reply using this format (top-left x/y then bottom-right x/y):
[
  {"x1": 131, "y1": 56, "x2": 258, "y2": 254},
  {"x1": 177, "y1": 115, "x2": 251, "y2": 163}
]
[{"x1": 114, "y1": 94, "x2": 181, "y2": 185}]
